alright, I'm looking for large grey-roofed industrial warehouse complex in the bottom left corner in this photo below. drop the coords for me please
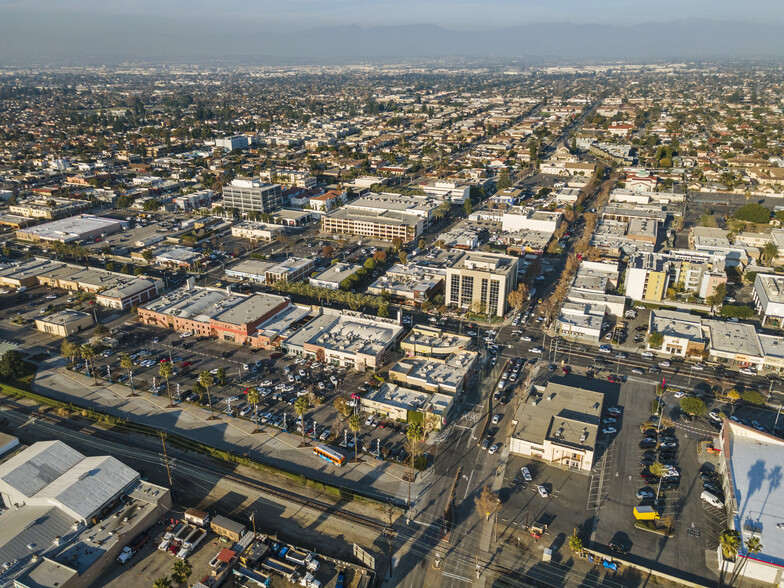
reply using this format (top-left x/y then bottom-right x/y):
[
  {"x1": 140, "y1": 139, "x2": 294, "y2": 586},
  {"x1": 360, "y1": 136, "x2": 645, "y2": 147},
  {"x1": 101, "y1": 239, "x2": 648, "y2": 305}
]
[{"x1": 0, "y1": 441, "x2": 171, "y2": 588}]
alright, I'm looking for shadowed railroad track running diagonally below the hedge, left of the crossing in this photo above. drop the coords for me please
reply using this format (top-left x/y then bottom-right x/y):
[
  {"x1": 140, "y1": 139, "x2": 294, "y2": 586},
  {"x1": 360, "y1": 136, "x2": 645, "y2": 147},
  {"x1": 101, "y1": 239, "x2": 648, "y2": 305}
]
[{"x1": 0, "y1": 397, "x2": 396, "y2": 535}]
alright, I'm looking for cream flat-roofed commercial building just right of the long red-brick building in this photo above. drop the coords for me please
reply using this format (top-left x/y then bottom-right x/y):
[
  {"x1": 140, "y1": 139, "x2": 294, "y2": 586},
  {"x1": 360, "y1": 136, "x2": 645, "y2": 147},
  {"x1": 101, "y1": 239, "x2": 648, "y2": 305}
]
[{"x1": 282, "y1": 308, "x2": 404, "y2": 370}]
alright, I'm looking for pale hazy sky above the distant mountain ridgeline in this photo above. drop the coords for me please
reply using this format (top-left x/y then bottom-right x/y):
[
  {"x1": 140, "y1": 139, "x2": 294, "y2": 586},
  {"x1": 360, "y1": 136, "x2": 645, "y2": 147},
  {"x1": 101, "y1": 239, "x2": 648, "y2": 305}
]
[{"x1": 0, "y1": 0, "x2": 784, "y2": 30}]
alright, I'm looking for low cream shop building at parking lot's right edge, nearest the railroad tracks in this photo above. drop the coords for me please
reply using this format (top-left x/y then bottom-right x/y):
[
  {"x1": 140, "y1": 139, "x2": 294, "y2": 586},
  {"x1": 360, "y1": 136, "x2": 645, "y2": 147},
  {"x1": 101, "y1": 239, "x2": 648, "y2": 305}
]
[{"x1": 360, "y1": 382, "x2": 454, "y2": 431}]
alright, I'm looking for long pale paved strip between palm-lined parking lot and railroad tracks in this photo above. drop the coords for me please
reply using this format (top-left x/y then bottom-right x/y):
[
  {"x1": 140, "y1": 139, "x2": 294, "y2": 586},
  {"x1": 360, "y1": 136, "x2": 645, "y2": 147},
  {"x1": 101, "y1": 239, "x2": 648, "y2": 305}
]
[{"x1": 32, "y1": 358, "x2": 426, "y2": 503}]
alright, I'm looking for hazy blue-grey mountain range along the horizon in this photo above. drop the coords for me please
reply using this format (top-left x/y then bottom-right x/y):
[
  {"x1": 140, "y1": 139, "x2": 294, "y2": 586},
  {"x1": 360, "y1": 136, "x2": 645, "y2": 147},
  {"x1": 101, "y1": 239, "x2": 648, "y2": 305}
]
[{"x1": 0, "y1": 15, "x2": 784, "y2": 64}]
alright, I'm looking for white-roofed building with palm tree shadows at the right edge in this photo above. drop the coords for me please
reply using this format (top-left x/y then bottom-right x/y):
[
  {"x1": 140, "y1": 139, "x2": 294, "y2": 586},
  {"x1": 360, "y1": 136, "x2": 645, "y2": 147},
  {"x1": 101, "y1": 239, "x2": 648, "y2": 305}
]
[{"x1": 717, "y1": 419, "x2": 784, "y2": 586}]
